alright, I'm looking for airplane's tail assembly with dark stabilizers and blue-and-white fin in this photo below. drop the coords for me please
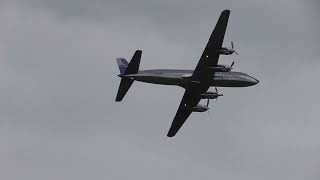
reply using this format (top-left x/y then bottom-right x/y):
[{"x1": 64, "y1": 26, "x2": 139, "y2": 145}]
[{"x1": 116, "y1": 50, "x2": 142, "y2": 102}]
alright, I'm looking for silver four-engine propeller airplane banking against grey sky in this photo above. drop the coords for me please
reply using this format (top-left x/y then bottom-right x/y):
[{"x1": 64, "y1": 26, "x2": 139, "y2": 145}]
[{"x1": 116, "y1": 10, "x2": 259, "y2": 137}]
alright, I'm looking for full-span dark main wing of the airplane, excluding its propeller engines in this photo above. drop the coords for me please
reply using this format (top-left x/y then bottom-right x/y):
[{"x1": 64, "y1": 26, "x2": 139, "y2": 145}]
[{"x1": 167, "y1": 10, "x2": 230, "y2": 137}]
